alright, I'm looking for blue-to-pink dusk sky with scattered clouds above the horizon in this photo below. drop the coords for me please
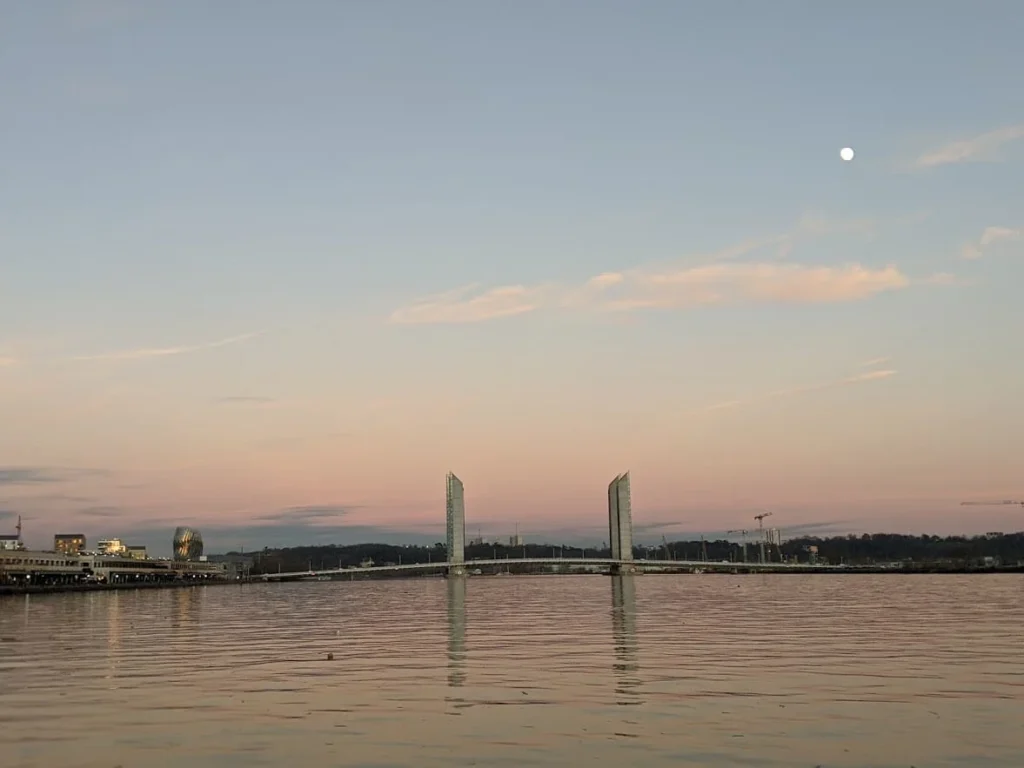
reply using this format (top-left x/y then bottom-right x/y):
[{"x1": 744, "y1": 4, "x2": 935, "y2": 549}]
[{"x1": 0, "y1": 0, "x2": 1024, "y2": 552}]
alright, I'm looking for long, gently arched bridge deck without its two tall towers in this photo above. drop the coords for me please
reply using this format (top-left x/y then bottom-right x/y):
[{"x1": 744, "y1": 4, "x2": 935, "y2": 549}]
[{"x1": 262, "y1": 557, "x2": 839, "y2": 580}]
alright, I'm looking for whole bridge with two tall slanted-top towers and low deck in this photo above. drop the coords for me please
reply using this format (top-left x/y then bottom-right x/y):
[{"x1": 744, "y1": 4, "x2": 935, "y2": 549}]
[{"x1": 262, "y1": 472, "x2": 838, "y2": 581}]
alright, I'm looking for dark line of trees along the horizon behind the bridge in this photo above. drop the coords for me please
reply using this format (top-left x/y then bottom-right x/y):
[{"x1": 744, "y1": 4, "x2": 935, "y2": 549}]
[{"x1": 235, "y1": 532, "x2": 1024, "y2": 574}]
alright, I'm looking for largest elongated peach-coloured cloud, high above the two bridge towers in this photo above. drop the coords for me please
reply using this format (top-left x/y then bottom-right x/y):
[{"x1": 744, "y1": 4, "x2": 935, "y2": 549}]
[{"x1": 391, "y1": 262, "x2": 910, "y2": 324}]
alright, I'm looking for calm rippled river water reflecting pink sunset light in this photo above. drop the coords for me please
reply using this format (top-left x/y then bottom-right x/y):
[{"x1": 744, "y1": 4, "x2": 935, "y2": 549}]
[{"x1": 0, "y1": 574, "x2": 1024, "y2": 768}]
